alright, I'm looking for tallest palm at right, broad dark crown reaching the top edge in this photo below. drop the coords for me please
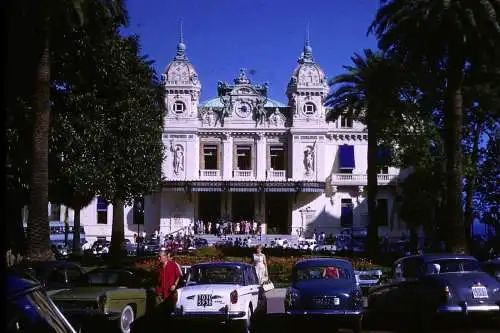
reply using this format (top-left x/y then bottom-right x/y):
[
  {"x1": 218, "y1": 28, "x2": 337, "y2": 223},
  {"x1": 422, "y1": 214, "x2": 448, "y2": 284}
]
[{"x1": 368, "y1": 0, "x2": 500, "y2": 252}]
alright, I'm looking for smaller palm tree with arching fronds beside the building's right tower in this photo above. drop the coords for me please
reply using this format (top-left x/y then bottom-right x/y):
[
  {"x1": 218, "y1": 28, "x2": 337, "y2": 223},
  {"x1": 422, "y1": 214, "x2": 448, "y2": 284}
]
[{"x1": 326, "y1": 50, "x2": 400, "y2": 255}]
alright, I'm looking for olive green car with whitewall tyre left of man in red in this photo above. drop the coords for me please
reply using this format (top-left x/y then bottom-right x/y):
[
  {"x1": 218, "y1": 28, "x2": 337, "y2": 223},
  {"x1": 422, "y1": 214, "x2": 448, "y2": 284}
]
[{"x1": 51, "y1": 268, "x2": 154, "y2": 333}]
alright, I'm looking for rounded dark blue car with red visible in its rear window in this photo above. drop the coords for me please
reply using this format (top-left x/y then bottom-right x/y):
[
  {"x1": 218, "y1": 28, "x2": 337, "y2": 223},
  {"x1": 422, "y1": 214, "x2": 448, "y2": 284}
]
[{"x1": 284, "y1": 258, "x2": 363, "y2": 333}]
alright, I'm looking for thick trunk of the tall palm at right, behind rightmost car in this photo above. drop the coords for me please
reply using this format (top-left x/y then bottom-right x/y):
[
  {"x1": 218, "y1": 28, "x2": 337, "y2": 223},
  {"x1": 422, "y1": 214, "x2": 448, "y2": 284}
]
[{"x1": 444, "y1": 66, "x2": 467, "y2": 253}]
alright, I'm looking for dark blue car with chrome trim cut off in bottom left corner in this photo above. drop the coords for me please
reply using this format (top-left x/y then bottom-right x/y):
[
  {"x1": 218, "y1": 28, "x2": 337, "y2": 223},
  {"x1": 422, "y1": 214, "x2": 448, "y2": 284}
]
[{"x1": 5, "y1": 270, "x2": 76, "y2": 333}]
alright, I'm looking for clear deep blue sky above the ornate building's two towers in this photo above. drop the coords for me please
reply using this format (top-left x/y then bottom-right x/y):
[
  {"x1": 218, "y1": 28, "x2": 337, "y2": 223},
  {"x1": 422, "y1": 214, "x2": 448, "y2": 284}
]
[{"x1": 121, "y1": 0, "x2": 379, "y2": 102}]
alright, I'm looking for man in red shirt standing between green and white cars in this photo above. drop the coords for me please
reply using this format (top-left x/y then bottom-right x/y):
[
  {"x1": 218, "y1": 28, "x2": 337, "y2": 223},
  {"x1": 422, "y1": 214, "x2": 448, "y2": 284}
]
[{"x1": 156, "y1": 250, "x2": 182, "y2": 311}]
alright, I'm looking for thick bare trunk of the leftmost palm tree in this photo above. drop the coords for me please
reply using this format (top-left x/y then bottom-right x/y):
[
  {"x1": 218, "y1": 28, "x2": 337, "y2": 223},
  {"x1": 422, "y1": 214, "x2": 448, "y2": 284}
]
[{"x1": 28, "y1": 37, "x2": 54, "y2": 260}]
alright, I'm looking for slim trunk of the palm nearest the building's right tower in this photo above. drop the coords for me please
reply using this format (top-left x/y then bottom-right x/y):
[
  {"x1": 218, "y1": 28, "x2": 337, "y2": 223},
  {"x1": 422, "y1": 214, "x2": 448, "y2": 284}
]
[{"x1": 366, "y1": 117, "x2": 379, "y2": 258}]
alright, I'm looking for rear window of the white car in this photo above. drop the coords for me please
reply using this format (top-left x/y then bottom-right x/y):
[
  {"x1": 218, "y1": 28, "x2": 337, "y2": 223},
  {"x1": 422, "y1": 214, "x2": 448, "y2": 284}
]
[{"x1": 188, "y1": 266, "x2": 244, "y2": 284}]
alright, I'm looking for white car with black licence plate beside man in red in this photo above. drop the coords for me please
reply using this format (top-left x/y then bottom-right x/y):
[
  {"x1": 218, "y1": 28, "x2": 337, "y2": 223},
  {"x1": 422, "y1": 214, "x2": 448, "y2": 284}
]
[{"x1": 173, "y1": 262, "x2": 267, "y2": 332}]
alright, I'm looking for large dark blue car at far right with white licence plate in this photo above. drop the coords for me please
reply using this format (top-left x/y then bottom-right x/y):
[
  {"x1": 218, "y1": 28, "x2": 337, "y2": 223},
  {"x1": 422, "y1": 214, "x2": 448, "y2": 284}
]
[{"x1": 368, "y1": 254, "x2": 500, "y2": 331}]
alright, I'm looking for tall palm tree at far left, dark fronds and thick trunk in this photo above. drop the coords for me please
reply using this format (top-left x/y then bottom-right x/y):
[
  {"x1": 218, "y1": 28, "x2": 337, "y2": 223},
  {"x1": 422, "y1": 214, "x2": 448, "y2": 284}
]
[{"x1": 15, "y1": 0, "x2": 127, "y2": 260}]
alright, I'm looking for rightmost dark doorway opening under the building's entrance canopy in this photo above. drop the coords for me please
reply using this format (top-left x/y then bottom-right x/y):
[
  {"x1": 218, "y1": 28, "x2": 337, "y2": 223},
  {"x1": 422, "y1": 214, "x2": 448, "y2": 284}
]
[{"x1": 266, "y1": 193, "x2": 289, "y2": 234}]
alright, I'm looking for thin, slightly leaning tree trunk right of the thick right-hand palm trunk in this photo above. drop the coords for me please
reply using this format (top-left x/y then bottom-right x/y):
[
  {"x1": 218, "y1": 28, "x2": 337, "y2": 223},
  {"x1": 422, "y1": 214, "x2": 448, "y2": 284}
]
[{"x1": 464, "y1": 120, "x2": 481, "y2": 250}]
